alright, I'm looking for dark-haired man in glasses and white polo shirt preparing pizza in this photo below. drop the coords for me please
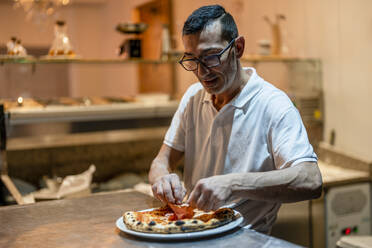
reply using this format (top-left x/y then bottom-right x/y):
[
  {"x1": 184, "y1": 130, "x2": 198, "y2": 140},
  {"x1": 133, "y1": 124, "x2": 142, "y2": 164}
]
[{"x1": 149, "y1": 5, "x2": 322, "y2": 233}]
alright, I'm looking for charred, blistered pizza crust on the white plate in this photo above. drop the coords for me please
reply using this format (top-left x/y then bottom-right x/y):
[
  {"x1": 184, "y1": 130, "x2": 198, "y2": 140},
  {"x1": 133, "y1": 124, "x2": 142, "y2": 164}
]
[{"x1": 123, "y1": 208, "x2": 236, "y2": 234}]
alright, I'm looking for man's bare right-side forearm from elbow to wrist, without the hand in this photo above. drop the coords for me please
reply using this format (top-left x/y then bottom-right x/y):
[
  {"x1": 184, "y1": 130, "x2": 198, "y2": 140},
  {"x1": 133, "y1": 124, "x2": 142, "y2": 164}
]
[{"x1": 230, "y1": 162, "x2": 322, "y2": 202}]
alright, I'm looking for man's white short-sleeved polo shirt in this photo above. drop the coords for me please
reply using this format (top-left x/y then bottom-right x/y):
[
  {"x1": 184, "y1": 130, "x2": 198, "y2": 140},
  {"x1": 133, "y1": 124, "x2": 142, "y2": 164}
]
[{"x1": 164, "y1": 68, "x2": 317, "y2": 232}]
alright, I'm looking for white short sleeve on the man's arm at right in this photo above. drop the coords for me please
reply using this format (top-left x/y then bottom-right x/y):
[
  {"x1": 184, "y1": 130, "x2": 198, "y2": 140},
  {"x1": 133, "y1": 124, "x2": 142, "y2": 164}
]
[{"x1": 269, "y1": 107, "x2": 317, "y2": 169}]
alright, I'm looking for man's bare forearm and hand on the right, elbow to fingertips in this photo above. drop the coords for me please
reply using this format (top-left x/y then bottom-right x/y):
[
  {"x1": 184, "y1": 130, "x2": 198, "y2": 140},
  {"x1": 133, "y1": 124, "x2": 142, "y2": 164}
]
[{"x1": 187, "y1": 162, "x2": 323, "y2": 207}]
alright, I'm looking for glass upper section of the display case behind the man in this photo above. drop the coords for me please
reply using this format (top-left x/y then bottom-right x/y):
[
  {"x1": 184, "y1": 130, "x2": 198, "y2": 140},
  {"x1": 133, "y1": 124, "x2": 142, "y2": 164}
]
[{"x1": 0, "y1": 56, "x2": 322, "y2": 137}]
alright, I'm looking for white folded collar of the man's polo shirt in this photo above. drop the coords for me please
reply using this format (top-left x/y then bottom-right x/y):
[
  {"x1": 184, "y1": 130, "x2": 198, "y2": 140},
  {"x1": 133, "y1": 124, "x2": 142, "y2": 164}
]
[{"x1": 203, "y1": 67, "x2": 263, "y2": 108}]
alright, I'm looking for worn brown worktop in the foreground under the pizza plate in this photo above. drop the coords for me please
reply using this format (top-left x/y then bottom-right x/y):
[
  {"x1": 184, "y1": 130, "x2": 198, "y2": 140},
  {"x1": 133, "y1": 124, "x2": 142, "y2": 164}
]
[{"x1": 0, "y1": 191, "x2": 299, "y2": 248}]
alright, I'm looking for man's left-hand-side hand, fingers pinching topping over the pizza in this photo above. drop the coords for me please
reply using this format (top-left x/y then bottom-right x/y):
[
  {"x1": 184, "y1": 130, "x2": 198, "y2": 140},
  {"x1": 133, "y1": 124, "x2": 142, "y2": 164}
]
[{"x1": 152, "y1": 173, "x2": 186, "y2": 204}]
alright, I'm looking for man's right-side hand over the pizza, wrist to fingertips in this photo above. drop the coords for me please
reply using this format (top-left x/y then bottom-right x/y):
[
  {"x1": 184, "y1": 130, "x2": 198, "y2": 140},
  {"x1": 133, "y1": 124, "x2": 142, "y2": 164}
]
[{"x1": 187, "y1": 175, "x2": 232, "y2": 211}]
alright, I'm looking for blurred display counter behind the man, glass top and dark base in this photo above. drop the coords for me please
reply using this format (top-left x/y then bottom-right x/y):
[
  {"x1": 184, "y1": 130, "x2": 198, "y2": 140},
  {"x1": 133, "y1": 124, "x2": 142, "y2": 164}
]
[{"x1": 0, "y1": 56, "x2": 322, "y2": 205}]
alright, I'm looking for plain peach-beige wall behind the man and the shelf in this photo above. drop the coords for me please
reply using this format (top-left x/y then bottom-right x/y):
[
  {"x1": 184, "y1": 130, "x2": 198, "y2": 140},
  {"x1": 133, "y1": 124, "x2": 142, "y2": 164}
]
[{"x1": 0, "y1": 0, "x2": 372, "y2": 159}]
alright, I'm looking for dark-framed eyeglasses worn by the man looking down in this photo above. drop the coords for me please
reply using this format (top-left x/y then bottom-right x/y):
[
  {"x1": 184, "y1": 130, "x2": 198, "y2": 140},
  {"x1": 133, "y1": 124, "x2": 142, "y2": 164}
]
[{"x1": 178, "y1": 39, "x2": 235, "y2": 71}]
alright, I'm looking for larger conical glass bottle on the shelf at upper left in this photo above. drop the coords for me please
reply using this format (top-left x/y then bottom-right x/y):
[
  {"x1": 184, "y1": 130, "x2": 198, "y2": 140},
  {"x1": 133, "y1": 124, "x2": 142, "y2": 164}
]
[{"x1": 49, "y1": 21, "x2": 75, "y2": 56}]
